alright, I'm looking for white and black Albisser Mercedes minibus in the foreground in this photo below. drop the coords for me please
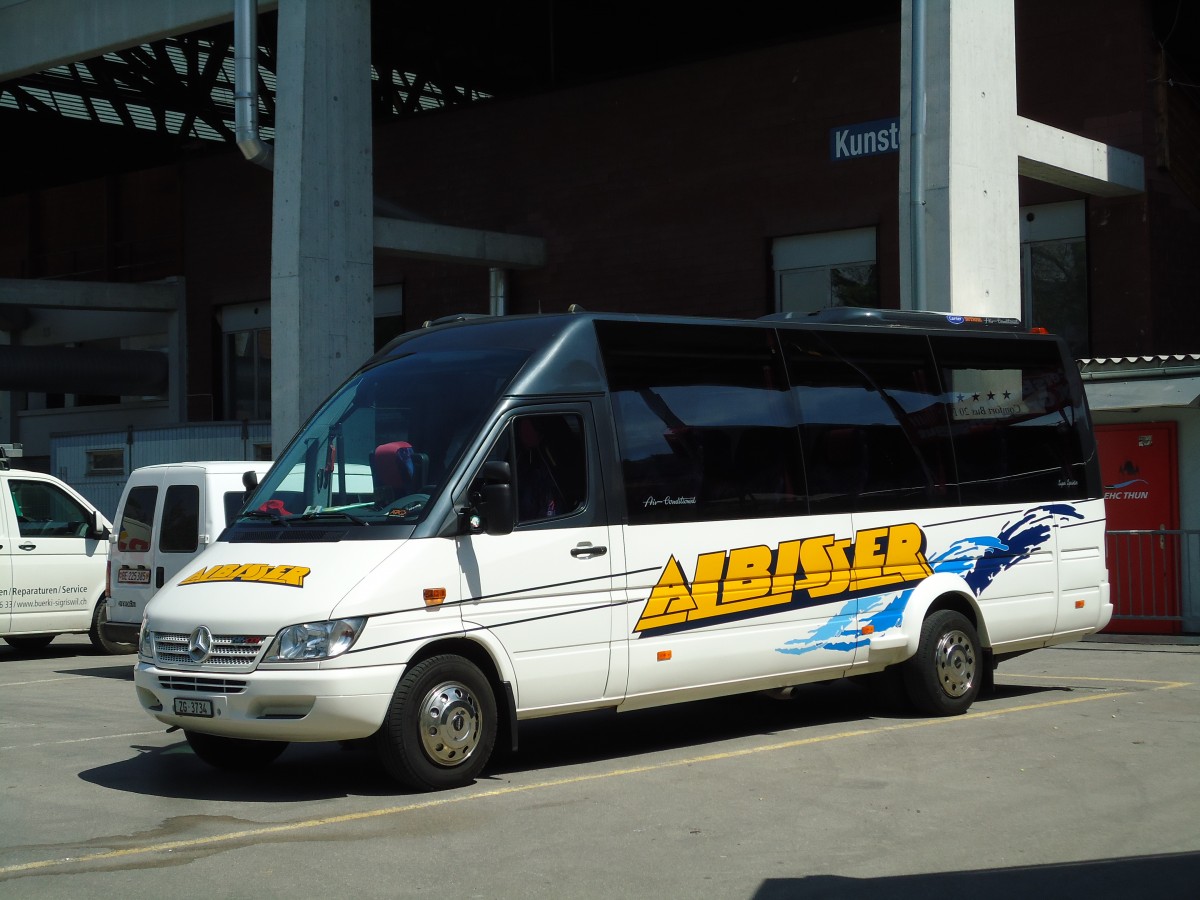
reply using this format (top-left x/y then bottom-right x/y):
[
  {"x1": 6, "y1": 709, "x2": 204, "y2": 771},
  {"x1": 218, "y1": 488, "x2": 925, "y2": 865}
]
[{"x1": 134, "y1": 310, "x2": 1112, "y2": 790}]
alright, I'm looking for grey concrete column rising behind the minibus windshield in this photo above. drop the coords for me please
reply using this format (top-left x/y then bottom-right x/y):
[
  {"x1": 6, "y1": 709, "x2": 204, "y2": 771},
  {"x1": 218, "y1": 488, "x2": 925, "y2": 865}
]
[{"x1": 271, "y1": 0, "x2": 374, "y2": 454}]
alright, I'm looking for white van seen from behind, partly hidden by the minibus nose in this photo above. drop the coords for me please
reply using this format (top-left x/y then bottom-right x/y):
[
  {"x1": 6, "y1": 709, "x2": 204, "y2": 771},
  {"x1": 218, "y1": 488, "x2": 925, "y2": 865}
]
[{"x1": 101, "y1": 460, "x2": 271, "y2": 644}]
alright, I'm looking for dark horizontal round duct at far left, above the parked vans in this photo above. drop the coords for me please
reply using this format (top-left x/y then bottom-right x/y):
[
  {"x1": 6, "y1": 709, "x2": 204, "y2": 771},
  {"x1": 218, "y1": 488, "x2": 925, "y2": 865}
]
[{"x1": 0, "y1": 347, "x2": 170, "y2": 397}]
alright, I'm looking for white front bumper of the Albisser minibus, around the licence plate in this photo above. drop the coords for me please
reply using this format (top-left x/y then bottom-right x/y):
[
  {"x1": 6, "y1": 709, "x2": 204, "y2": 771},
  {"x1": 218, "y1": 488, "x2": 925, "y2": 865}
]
[{"x1": 133, "y1": 661, "x2": 404, "y2": 742}]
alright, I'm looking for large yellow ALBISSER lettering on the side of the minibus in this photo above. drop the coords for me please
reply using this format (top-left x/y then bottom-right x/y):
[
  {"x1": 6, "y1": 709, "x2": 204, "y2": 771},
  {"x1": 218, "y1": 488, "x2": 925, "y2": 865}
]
[{"x1": 634, "y1": 522, "x2": 932, "y2": 634}]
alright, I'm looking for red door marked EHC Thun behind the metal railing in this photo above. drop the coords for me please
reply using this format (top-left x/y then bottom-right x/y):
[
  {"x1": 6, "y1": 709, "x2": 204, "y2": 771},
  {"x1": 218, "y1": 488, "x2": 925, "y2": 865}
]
[{"x1": 1096, "y1": 422, "x2": 1182, "y2": 634}]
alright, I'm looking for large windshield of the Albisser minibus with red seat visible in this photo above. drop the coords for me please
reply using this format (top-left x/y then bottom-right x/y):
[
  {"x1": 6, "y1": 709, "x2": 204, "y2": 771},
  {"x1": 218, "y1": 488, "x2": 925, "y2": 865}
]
[{"x1": 239, "y1": 349, "x2": 528, "y2": 524}]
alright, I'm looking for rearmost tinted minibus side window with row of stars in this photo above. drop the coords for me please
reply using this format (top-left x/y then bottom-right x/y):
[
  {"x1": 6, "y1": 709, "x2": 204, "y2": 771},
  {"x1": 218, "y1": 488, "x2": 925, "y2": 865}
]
[{"x1": 932, "y1": 337, "x2": 1092, "y2": 504}]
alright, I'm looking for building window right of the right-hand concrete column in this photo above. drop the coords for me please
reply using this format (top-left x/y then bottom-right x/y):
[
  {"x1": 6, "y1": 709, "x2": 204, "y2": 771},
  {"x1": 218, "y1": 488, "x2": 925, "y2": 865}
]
[{"x1": 1021, "y1": 200, "x2": 1091, "y2": 359}]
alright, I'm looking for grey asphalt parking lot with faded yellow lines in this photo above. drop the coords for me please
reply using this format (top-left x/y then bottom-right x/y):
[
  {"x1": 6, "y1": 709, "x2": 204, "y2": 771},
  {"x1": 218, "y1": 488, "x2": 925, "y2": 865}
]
[{"x1": 0, "y1": 636, "x2": 1200, "y2": 900}]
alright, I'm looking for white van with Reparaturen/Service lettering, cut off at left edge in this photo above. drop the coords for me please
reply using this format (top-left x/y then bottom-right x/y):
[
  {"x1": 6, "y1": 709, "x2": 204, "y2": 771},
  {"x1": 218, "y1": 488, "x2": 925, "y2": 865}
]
[{"x1": 0, "y1": 452, "x2": 120, "y2": 653}]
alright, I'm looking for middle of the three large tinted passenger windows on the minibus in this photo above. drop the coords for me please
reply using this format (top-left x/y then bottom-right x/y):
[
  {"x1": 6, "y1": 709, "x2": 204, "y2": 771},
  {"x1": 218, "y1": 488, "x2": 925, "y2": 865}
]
[{"x1": 781, "y1": 331, "x2": 958, "y2": 512}]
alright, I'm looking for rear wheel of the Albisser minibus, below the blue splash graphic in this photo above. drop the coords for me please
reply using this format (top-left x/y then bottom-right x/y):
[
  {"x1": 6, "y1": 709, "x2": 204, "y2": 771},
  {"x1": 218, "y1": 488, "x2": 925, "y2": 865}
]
[{"x1": 904, "y1": 610, "x2": 985, "y2": 715}]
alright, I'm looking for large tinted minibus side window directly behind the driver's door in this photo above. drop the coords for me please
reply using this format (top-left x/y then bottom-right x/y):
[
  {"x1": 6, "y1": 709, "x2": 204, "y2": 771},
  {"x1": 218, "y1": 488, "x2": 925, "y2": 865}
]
[{"x1": 596, "y1": 322, "x2": 805, "y2": 524}]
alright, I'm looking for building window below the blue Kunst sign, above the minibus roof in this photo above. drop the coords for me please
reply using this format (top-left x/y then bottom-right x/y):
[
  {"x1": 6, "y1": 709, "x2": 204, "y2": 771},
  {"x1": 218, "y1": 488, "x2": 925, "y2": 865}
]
[{"x1": 772, "y1": 228, "x2": 880, "y2": 312}]
